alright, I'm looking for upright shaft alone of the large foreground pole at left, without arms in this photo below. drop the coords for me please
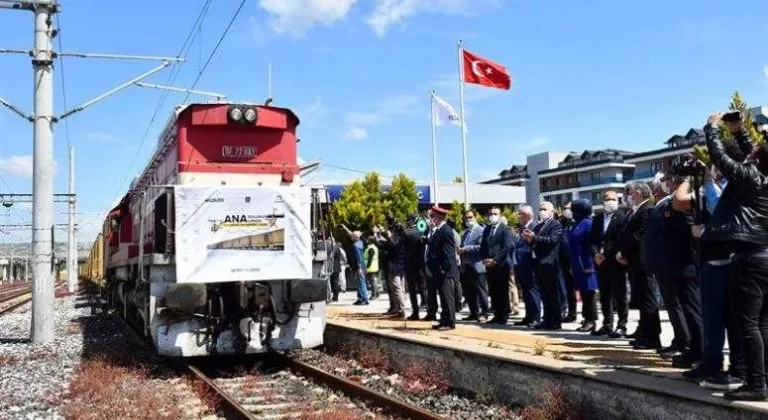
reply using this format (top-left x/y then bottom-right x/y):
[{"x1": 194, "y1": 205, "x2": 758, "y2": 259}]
[{"x1": 32, "y1": 2, "x2": 56, "y2": 344}]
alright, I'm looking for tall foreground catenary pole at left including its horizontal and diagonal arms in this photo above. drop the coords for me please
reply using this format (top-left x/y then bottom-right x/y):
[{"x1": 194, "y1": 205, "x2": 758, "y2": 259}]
[{"x1": 0, "y1": 0, "x2": 184, "y2": 344}]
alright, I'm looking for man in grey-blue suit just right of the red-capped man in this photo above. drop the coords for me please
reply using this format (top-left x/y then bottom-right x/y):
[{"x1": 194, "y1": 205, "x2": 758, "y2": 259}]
[{"x1": 459, "y1": 210, "x2": 490, "y2": 322}]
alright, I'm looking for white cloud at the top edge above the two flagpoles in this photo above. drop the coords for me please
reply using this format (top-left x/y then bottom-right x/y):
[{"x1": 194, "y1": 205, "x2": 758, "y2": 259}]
[{"x1": 366, "y1": 0, "x2": 501, "y2": 36}]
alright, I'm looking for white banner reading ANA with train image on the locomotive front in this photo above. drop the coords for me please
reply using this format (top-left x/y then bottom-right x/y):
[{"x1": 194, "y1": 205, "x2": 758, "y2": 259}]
[{"x1": 174, "y1": 186, "x2": 312, "y2": 283}]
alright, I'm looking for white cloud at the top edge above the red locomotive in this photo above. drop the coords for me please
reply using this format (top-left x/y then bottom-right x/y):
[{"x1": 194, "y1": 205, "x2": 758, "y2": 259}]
[{"x1": 259, "y1": 0, "x2": 357, "y2": 37}]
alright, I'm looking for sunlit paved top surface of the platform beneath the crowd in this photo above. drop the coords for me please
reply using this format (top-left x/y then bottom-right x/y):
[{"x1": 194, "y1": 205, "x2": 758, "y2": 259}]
[{"x1": 327, "y1": 291, "x2": 768, "y2": 418}]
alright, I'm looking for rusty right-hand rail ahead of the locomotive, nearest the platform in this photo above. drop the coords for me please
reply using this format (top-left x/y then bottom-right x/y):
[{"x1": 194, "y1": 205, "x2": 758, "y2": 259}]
[{"x1": 283, "y1": 356, "x2": 443, "y2": 420}]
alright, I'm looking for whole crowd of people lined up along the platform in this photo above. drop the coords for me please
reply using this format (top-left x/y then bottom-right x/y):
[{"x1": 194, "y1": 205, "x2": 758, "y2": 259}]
[{"x1": 331, "y1": 114, "x2": 768, "y2": 401}]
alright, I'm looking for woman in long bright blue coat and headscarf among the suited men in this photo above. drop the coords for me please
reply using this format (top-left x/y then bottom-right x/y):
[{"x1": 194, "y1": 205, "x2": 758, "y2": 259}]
[{"x1": 568, "y1": 198, "x2": 597, "y2": 332}]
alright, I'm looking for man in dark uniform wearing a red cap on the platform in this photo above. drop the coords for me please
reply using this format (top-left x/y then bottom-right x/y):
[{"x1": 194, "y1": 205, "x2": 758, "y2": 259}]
[{"x1": 427, "y1": 206, "x2": 459, "y2": 331}]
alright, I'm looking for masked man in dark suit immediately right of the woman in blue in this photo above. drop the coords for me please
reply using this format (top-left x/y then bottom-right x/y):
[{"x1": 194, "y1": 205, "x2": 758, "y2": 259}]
[{"x1": 590, "y1": 191, "x2": 629, "y2": 338}]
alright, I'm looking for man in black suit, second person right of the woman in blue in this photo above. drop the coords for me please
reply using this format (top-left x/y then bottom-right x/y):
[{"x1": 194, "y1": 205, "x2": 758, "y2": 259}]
[{"x1": 616, "y1": 182, "x2": 661, "y2": 350}]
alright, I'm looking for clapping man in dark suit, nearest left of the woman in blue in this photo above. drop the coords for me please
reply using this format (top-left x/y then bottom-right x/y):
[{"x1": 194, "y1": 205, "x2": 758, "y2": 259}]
[{"x1": 523, "y1": 201, "x2": 563, "y2": 330}]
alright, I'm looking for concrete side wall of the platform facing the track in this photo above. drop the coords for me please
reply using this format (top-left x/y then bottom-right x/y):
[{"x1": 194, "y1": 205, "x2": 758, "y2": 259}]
[{"x1": 325, "y1": 320, "x2": 768, "y2": 420}]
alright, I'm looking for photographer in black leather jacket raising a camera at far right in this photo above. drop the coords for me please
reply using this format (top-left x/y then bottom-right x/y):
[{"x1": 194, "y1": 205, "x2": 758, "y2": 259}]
[{"x1": 703, "y1": 113, "x2": 768, "y2": 401}]
